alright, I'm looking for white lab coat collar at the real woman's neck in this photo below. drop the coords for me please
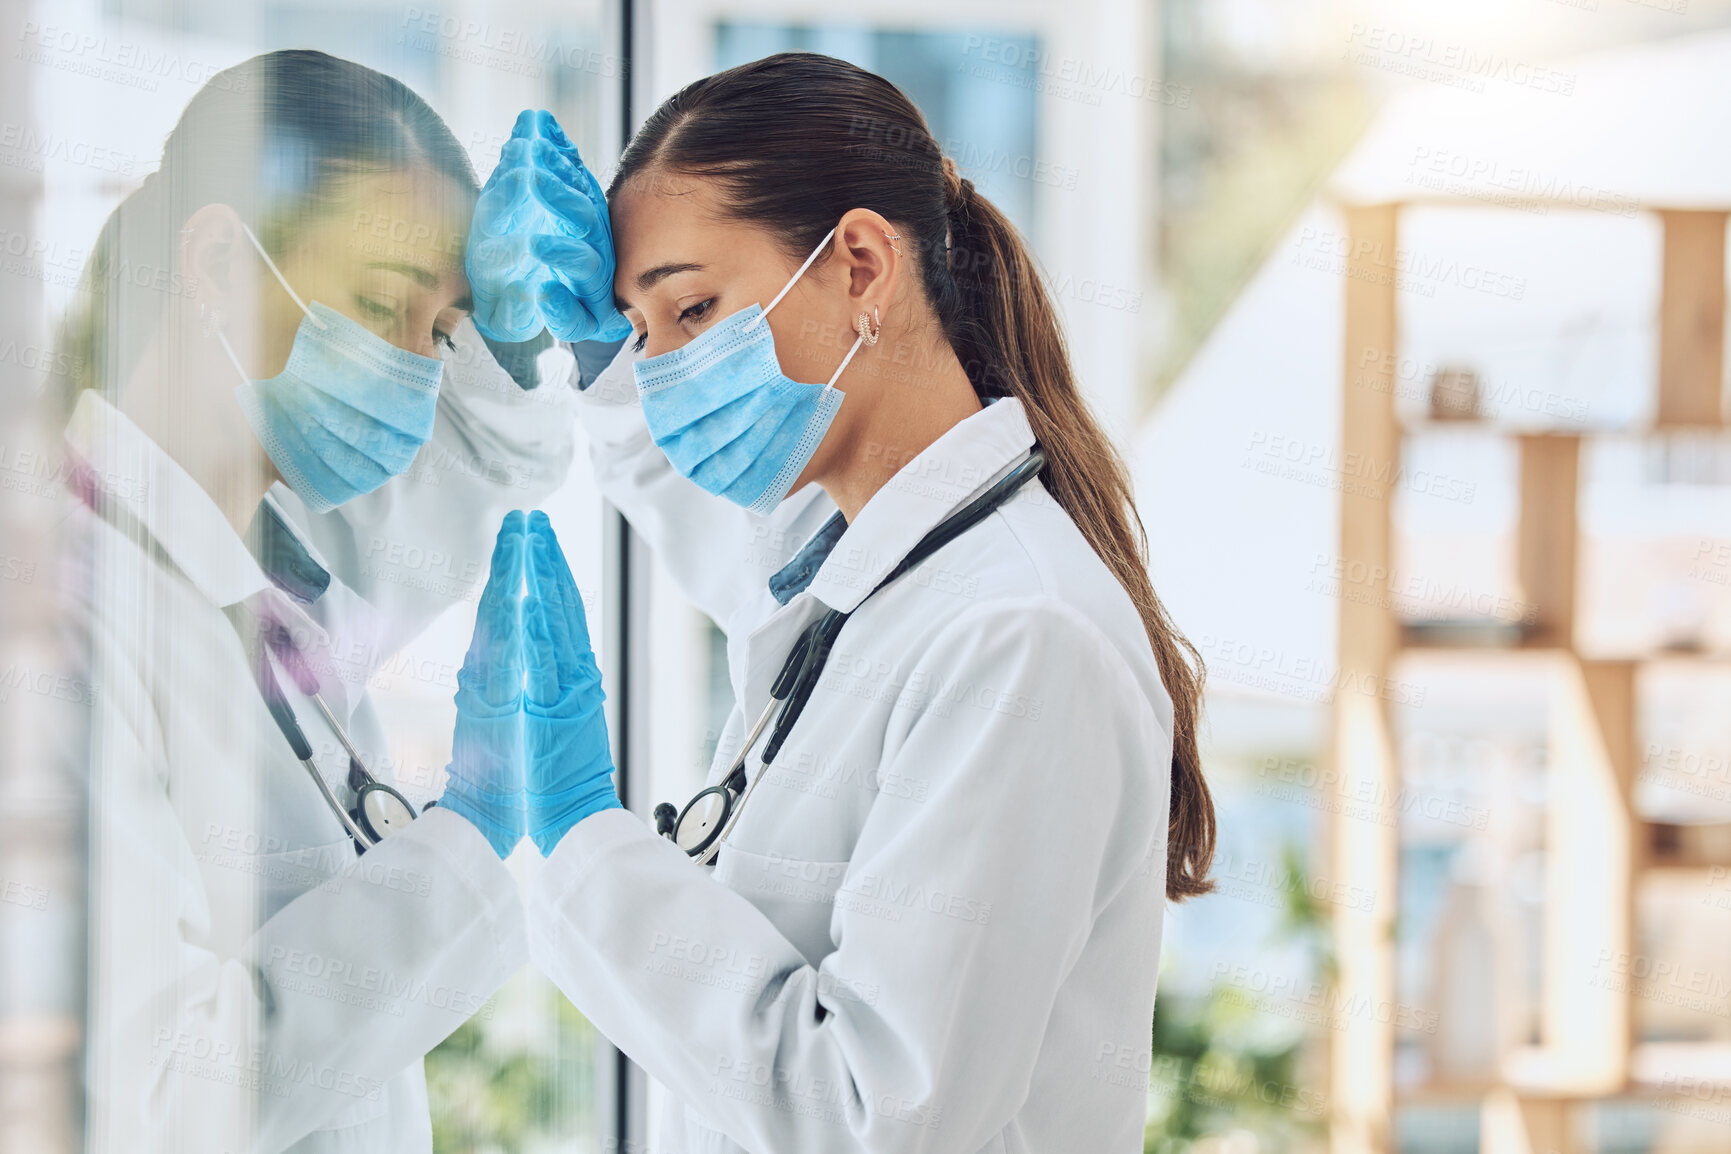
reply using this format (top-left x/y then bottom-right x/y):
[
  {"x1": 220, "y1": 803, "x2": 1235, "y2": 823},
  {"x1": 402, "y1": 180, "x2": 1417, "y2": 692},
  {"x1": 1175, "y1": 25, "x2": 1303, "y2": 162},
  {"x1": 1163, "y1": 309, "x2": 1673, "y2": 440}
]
[{"x1": 803, "y1": 396, "x2": 1033, "y2": 612}]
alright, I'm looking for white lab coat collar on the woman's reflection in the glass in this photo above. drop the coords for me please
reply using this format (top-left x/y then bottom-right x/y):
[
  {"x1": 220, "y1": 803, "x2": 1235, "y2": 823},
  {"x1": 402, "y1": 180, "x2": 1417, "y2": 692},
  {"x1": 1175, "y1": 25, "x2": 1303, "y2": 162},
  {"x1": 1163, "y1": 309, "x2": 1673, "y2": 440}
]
[{"x1": 66, "y1": 389, "x2": 272, "y2": 607}]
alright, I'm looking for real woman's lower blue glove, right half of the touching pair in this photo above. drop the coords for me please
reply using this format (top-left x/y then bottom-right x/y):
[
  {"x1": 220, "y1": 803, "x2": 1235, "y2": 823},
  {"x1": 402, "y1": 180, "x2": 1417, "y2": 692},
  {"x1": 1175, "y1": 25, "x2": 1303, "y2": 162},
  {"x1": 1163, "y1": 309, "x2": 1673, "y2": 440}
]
[{"x1": 523, "y1": 510, "x2": 620, "y2": 856}]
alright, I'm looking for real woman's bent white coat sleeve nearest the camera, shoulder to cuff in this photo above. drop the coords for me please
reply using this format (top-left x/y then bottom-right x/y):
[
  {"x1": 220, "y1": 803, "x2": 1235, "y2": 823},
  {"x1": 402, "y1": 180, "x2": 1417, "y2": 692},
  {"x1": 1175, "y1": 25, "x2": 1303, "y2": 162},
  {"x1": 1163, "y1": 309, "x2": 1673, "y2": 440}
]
[{"x1": 530, "y1": 597, "x2": 1167, "y2": 1154}]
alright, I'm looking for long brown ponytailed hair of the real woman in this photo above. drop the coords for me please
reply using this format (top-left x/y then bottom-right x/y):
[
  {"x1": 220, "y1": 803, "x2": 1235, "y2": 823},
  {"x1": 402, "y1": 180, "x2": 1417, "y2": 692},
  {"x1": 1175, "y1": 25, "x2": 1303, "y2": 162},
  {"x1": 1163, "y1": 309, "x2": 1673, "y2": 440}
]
[{"x1": 608, "y1": 52, "x2": 1215, "y2": 901}]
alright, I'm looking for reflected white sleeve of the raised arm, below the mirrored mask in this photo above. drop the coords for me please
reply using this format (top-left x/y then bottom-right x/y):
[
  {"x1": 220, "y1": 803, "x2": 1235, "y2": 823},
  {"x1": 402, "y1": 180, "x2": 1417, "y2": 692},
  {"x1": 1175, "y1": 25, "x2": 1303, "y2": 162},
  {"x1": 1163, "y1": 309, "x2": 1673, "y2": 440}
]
[{"x1": 272, "y1": 320, "x2": 575, "y2": 661}]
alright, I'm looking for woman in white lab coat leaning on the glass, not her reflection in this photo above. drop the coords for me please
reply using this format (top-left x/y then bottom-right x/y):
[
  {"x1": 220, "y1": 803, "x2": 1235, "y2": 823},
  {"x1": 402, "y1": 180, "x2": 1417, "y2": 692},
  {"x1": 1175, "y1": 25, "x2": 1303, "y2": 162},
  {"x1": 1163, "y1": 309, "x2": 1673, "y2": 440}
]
[{"x1": 508, "y1": 54, "x2": 1213, "y2": 1154}]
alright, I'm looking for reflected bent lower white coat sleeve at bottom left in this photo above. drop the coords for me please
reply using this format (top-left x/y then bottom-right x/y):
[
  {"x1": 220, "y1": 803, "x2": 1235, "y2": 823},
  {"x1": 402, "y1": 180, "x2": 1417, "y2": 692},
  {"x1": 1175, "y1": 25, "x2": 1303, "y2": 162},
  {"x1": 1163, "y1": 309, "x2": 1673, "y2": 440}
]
[{"x1": 90, "y1": 650, "x2": 528, "y2": 1154}]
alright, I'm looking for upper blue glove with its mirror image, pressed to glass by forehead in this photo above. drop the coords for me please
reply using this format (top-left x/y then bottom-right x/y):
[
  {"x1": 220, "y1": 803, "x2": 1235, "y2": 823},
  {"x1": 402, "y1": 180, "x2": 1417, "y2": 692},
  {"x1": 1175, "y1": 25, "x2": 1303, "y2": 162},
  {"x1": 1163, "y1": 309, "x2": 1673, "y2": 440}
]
[{"x1": 464, "y1": 111, "x2": 630, "y2": 341}]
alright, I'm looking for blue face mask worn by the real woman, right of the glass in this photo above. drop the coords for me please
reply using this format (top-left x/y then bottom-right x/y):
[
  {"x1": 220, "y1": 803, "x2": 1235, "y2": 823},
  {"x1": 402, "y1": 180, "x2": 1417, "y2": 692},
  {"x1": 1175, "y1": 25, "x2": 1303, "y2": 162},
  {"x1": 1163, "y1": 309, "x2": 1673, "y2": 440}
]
[{"x1": 635, "y1": 228, "x2": 864, "y2": 514}]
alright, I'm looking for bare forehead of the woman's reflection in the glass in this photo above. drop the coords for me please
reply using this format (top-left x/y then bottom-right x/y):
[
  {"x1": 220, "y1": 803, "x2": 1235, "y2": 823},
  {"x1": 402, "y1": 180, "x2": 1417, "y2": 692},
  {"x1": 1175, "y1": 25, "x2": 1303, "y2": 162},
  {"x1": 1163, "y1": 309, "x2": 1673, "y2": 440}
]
[{"x1": 325, "y1": 170, "x2": 474, "y2": 275}]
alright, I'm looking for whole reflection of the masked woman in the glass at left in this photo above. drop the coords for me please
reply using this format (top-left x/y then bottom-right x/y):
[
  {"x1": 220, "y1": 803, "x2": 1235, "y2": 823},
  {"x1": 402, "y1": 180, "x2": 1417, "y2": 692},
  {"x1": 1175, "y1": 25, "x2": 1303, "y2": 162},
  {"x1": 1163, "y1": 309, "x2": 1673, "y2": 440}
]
[{"x1": 54, "y1": 52, "x2": 569, "y2": 1152}]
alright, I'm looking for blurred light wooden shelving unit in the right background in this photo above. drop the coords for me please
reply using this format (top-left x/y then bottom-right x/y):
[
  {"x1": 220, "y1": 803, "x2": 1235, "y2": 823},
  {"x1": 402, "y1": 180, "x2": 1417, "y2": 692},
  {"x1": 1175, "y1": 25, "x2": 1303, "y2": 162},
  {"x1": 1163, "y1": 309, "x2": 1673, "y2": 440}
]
[{"x1": 1326, "y1": 202, "x2": 1731, "y2": 1154}]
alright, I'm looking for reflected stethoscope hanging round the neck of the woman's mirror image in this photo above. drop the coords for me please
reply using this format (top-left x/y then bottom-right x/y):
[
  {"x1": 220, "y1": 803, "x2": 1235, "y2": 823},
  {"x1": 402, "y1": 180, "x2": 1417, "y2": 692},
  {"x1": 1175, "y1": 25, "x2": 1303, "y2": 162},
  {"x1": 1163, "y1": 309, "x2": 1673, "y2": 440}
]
[{"x1": 71, "y1": 462, "x2": 425, "y2": 853}]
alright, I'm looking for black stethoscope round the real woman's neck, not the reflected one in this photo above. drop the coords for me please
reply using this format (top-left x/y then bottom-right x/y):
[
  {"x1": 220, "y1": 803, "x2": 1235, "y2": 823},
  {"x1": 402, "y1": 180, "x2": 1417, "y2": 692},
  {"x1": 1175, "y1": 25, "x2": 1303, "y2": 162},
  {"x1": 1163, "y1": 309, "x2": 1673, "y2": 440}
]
[{"x1": 654, "y1": 448, "x2": 1046, "y2": 865}]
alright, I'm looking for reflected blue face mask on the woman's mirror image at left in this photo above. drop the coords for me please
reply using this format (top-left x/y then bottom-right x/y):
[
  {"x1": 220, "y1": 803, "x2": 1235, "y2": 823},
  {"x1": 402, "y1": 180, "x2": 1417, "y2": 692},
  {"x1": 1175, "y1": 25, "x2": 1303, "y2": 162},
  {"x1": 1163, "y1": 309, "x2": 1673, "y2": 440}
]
[{"x1": 216, "y1": 225, "x2": 445, "y2": 512}]
